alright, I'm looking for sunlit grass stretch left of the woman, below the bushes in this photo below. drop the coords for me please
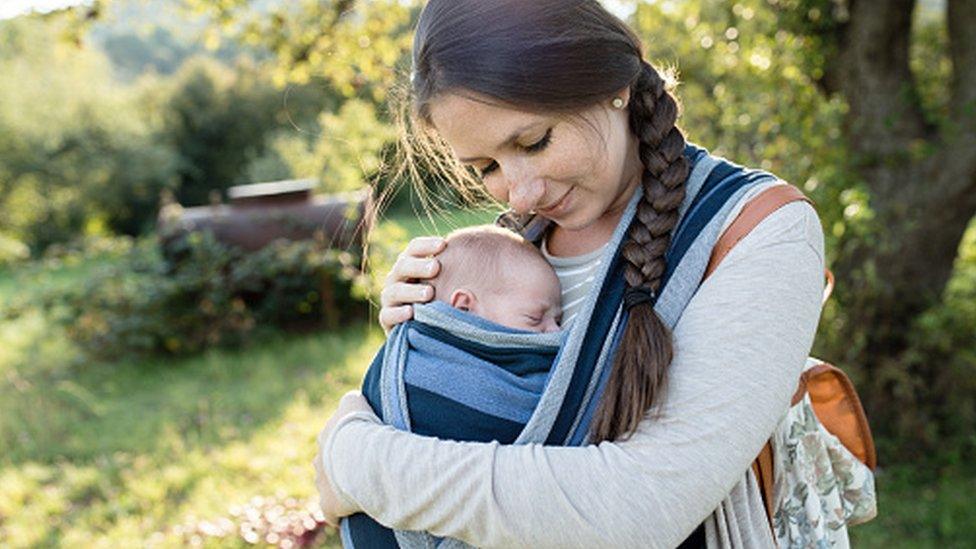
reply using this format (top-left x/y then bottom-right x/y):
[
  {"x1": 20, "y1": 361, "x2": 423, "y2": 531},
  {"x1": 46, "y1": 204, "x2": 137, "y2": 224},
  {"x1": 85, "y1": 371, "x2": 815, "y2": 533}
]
[{"x1": 0, "y1": 312, "x2": 382, "y2": 547}]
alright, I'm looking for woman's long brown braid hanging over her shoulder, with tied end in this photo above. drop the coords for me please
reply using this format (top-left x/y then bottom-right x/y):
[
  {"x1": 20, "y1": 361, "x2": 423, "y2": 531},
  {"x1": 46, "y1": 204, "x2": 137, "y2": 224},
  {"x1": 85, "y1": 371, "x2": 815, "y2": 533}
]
[{"x1": 590, "y1": 62, "x2": 688, "y2": 442}]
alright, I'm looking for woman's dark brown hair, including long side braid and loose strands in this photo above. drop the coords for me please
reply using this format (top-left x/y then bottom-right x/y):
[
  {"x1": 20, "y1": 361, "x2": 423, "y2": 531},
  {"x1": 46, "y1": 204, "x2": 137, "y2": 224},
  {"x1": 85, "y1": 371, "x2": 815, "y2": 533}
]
[{"x1": 400, "y1": 0, "x2": 689, "y2": 442}]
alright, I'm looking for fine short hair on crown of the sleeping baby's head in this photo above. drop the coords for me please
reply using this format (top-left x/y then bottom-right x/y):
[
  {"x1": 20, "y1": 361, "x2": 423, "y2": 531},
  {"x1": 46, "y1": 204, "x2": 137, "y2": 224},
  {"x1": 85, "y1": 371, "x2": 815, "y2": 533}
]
[{"x1": 430, "y1": 225, "x2": 552, "y2": 301}]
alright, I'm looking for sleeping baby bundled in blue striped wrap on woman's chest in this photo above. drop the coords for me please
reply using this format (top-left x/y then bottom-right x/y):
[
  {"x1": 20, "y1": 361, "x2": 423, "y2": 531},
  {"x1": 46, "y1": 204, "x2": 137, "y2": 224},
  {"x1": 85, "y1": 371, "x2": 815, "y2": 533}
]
[{"x1": 341, "y1": 225, "x2": 562, "y2": 548}]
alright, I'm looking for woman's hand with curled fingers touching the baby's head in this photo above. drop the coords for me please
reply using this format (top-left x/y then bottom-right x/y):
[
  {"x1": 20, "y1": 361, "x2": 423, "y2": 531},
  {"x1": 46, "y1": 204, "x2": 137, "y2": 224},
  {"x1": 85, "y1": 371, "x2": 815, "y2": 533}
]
[{"x1": 379, "y1": 236, "x2": 447, "y2": 333}]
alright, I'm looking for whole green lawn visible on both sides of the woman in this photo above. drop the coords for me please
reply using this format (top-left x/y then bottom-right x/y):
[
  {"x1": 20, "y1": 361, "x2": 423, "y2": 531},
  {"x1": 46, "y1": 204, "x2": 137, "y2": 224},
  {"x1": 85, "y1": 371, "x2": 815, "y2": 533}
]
[{"x1": 0, "y1": 207, "x2": 976, "y2": 547}]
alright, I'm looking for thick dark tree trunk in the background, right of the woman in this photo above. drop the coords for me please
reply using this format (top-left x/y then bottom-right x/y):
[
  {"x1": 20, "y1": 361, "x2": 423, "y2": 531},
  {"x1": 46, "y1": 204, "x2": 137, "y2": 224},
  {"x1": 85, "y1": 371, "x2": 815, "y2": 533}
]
[{"x1": 822, "y1": 0, "x2": 976, "y2": 448}]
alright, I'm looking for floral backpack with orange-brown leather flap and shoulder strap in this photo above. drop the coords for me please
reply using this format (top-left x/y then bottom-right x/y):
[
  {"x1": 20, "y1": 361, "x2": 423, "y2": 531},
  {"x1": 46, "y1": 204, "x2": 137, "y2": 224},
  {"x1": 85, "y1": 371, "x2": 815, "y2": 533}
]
[{"x1": 703, "y1": 185, "x2": 877, "y2": 548}]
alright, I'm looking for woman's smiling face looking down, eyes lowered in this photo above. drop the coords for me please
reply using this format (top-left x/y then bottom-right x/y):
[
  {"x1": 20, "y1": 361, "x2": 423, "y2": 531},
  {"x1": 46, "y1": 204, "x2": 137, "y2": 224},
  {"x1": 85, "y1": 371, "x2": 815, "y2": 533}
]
[{"x1": 430, "y1": 91, "x2": 642, "y2": 230}]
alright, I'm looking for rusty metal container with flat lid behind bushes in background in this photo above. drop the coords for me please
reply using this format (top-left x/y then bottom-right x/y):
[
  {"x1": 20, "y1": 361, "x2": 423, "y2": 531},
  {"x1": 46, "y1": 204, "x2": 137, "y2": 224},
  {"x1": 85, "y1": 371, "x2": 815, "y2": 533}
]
[{"x1": 159, "y1": 179, "x2": 373, "y2": 251}]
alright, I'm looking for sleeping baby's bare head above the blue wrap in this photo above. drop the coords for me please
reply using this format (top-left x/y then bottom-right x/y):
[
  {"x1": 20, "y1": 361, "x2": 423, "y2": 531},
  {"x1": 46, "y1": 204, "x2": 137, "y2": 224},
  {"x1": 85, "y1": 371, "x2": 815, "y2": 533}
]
[{"x1": 430, "y1": 225, "x2": 562, "y2": 332}]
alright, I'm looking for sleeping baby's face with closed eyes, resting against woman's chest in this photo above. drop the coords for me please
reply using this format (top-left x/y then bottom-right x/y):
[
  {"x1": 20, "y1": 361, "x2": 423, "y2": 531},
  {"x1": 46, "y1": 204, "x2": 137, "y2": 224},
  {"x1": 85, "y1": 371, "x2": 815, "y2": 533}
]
[{"x1": 471, "y1": 264, "x2": 562, "y2": 332}]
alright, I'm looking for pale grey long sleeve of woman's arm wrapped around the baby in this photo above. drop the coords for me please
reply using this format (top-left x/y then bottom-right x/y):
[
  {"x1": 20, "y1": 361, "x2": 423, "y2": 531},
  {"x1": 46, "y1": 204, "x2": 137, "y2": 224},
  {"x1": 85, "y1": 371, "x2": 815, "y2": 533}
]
[{"x1": 323, "y1": 203, "x2": 823, "y2": 547}]
